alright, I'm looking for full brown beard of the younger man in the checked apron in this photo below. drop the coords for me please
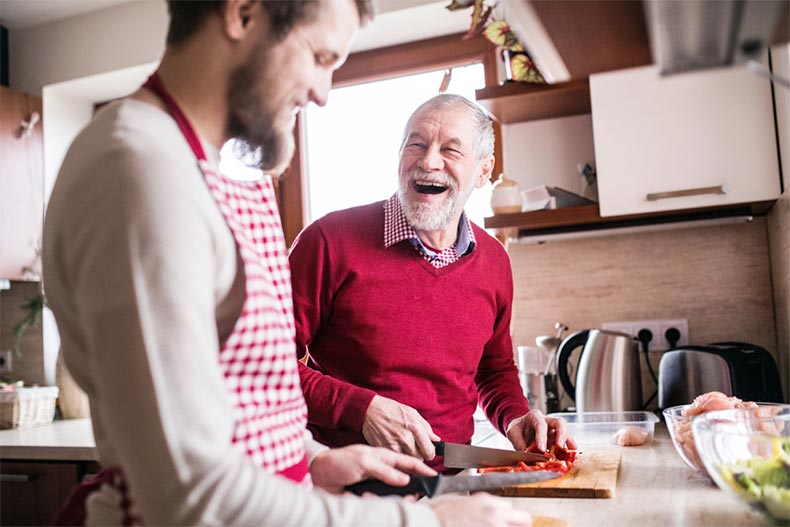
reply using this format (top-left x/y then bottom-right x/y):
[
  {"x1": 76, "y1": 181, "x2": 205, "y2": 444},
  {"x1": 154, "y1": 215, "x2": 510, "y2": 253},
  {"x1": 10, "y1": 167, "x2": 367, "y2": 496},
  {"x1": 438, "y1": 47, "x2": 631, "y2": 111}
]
[{"x1": 227, "y1": 47, "x2": 294, "y2": 175}]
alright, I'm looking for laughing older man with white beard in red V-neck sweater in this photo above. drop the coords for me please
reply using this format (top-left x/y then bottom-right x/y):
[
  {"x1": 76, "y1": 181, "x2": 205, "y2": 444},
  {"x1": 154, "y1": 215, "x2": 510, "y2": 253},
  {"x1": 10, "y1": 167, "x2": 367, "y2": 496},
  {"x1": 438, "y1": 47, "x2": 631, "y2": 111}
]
[{"x1": 289, "y1": 95, "x2": 575, "y2": 466}]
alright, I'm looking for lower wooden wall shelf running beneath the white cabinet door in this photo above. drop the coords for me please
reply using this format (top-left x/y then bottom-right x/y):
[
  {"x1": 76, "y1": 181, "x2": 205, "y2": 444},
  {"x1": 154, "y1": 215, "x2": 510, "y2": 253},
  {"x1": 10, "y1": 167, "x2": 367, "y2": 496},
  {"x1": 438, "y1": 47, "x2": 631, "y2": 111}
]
[{"x1": 485, "y1": 200, "x2": 774, "y2": 236}]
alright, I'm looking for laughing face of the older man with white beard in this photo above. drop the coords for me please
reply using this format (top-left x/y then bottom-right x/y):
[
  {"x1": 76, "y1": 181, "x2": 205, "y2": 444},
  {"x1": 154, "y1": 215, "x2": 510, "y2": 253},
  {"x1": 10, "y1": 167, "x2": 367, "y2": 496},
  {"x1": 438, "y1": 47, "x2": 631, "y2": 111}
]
[{"x1": 398, "y1": 106, "x2": 490, "y2": 231}]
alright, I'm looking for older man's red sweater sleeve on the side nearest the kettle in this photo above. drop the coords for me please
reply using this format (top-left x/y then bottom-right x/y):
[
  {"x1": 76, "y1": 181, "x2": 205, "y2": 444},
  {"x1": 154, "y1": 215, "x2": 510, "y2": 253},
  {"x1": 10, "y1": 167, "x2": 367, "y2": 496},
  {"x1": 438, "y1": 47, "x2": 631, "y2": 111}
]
[{"x1": 475, "y1": 247, "x2": 529, "y2": 434}]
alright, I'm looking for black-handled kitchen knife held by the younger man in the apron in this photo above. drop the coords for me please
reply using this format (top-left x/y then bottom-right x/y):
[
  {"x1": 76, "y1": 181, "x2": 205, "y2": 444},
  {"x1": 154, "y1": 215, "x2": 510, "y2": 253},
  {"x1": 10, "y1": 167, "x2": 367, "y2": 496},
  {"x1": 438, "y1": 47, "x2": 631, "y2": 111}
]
[{"x1": 346, "y1": 470, "x2": 562, "y2": 497}]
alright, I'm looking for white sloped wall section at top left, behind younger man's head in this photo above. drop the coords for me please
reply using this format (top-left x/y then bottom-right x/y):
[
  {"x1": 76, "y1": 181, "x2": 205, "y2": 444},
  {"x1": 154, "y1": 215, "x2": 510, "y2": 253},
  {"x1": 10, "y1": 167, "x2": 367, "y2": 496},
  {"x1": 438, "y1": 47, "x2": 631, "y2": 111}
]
[{"x1": 8, "y1": 0, "x2": 168, "y2": 95}]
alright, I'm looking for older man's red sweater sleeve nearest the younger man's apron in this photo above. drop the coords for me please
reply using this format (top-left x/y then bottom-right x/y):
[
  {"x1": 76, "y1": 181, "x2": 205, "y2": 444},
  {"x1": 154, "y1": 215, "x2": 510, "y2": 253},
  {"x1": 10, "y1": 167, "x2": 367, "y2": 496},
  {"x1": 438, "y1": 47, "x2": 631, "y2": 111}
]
[{"x1": 289, "y1": 220, "x2": 376, "y2": 431}]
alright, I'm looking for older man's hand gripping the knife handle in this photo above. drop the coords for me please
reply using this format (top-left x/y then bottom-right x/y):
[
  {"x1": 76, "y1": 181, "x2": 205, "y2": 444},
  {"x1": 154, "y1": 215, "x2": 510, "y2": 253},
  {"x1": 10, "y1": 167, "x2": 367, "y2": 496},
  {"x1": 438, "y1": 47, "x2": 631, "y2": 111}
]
[{"x1": 362, "y1": 395, "x2": 440, "y2": 460}]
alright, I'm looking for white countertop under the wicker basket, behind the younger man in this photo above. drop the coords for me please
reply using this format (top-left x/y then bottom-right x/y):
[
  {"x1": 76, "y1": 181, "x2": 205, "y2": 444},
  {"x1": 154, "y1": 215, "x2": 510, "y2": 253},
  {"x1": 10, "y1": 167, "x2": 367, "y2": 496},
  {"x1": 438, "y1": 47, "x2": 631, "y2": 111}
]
[{"x1": 0, "y1": 419, "x2": 99, "y2": 461}]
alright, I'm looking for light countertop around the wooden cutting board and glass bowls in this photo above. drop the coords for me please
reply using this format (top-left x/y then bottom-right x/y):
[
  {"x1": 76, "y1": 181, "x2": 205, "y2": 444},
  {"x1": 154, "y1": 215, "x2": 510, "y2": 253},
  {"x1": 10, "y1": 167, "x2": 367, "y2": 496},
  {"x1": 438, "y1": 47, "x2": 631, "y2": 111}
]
[{"x1": 478, "y1": 423, "x2": 771, "y2": 527}]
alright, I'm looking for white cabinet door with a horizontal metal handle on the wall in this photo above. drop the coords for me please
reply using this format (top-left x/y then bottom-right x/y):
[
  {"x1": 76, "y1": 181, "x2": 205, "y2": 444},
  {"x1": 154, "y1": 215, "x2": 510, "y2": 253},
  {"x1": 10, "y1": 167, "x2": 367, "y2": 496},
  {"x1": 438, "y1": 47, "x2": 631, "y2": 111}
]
[{"x1": 590, "y1": 66, "x2": 780, "y2": 216}]
